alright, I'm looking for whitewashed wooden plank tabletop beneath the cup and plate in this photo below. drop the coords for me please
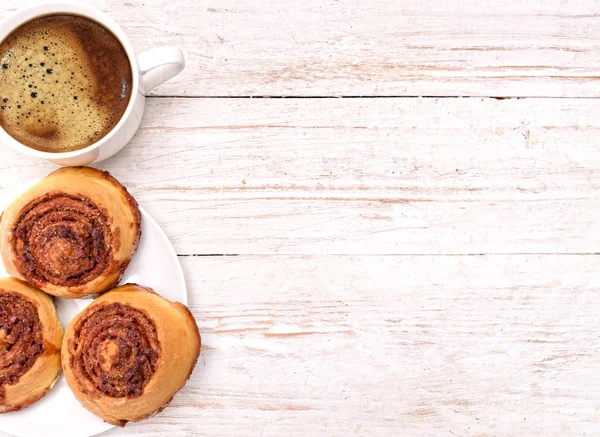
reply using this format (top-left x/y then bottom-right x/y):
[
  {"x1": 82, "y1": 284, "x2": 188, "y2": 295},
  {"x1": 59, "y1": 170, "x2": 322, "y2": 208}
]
[{"x1": 0, "y1": 0, "x2": 600, "y2": 437}]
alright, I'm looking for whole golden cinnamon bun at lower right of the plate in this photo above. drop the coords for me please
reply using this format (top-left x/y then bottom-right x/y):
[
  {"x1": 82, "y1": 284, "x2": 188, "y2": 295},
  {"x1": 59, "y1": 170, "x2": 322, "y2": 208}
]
[{"x1": 62, "y1": 284, "x2": 200, "y2": 426}]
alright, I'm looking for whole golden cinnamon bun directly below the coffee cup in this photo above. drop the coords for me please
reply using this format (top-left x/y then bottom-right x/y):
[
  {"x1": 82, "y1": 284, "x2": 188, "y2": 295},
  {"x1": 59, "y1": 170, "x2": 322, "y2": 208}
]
[{"x1": 0, "y1": 167, "x2": 141, "y2": 298}]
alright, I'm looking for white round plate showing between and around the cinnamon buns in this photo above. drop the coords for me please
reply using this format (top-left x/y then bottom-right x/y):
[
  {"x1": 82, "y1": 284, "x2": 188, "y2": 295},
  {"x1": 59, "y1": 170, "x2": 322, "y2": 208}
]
[{"x1": 0, "y1": 198, "x2": 187, "y2": 437}]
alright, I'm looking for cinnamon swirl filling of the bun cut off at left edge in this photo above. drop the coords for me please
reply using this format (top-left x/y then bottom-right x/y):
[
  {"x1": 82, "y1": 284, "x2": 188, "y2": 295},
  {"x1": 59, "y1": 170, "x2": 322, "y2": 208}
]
[{"x1": 0, "y1": 290, "x2": 44, "y2": 402}]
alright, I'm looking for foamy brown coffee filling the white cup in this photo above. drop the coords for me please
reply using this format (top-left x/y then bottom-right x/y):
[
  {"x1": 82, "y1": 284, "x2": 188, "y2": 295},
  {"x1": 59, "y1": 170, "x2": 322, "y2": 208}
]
[{"x1": 0, "y1": 15, "x2": 132, "y2": 152}]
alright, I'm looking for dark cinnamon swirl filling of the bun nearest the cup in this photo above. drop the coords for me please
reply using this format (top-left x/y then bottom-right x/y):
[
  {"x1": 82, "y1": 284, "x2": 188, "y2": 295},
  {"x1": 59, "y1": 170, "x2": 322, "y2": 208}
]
[{"x1": 13, "y1": 192, "x2": 112, "y2": 287}]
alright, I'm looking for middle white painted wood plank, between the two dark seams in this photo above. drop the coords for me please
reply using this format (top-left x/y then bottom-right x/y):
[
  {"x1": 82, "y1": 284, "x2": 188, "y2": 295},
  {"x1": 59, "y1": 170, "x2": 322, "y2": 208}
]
[{"x1": 0, "y1": 99, "x2": 600, "y2": 254}]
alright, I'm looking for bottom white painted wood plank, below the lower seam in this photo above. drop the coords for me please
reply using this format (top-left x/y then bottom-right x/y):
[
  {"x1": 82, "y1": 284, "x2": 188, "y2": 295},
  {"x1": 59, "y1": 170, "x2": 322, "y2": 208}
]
[{"x1": 10, "y1": 255, "x2": 600, "y2": 437}]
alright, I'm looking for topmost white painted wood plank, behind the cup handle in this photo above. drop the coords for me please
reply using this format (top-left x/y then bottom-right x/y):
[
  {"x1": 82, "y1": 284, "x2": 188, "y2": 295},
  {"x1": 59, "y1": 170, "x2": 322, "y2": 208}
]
[{"x1": 0, "y1": 0, "x2": 600, "y2": 97}]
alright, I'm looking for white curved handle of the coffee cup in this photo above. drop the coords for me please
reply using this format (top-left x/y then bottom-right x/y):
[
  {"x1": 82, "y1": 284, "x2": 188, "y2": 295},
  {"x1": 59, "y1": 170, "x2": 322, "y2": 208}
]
[{"x1": 137, "y1": 47, "x2": 185, "y2": 95}]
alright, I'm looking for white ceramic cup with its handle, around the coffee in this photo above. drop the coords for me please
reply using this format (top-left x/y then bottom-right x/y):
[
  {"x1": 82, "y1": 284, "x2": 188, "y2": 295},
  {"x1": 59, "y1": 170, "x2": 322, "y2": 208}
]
[{"x1": 0, "y1": 2, "x2": 185, "y2": 165}]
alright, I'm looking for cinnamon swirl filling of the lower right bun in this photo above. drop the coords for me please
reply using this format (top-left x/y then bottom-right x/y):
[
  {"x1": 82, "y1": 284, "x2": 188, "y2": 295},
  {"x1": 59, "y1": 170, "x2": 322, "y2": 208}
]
[{"x1": 69, "y1": 303, "x2": 160, "y2": 398}]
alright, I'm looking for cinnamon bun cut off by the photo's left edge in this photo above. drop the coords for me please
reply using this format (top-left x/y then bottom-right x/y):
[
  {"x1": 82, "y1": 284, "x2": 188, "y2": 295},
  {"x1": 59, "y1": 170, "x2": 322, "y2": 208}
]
[{"x1": 0, "y1": 278, "x2": 62, "y2": 413}]
